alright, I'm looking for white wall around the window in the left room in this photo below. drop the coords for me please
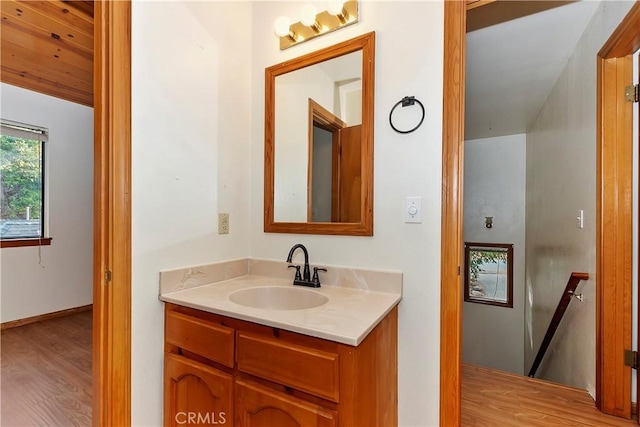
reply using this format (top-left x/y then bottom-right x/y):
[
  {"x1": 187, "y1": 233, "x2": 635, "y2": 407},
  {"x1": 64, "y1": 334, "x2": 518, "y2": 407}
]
[{"x1": 0, "y1": 83, "x2": 93, "y2": 322}]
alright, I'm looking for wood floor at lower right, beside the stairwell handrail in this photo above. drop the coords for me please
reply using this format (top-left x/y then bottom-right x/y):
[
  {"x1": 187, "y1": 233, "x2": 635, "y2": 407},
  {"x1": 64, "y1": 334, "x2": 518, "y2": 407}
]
[{"x1": 462, "y1": 365, "x2": 638, "y2": 427}]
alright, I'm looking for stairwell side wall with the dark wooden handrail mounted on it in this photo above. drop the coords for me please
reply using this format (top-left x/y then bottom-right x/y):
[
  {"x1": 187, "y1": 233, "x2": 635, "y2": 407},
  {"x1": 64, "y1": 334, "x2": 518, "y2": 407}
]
[{"x1": 525, "y1": 1, "x2": 633, "y2": 394}]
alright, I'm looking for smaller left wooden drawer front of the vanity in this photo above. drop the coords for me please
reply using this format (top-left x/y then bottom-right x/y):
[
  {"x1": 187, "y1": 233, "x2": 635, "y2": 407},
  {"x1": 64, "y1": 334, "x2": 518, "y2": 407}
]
[{"x1": 165, "y1": 311, "x2": 234, "y2": 368}]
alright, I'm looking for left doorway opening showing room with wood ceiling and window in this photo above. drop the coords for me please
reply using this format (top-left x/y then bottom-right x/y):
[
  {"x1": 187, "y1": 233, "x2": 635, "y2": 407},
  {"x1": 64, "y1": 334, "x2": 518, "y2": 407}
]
[{"x1": 0, "y1": 1, "x2": 93, "y2": 424}]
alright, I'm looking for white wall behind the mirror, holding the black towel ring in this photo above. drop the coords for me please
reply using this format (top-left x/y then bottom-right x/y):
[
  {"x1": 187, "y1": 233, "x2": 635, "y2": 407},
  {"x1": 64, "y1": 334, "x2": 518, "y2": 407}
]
[{"x1": 251, "y1": 1, "x2": 443, "y2": 426}]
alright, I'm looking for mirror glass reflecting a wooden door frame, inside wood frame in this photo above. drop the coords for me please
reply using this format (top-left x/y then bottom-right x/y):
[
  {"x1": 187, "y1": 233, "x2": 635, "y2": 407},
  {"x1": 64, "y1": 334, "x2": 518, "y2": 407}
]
[{"x1": 274, "y1": 51, "x2": 362, "y2": 222}]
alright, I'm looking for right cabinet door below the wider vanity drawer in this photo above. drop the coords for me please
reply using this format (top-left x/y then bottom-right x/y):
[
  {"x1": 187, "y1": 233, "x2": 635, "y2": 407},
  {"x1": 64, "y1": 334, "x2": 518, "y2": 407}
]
[{"x1": 236, "y1": 380, "x2": 337, "y2": 427}]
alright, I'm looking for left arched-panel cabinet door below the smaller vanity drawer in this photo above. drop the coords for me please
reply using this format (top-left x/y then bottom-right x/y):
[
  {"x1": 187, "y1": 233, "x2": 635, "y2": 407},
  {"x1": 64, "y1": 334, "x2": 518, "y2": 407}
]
[{"x1": 164, "y1": 353, "x2": 233, "y2": 426}]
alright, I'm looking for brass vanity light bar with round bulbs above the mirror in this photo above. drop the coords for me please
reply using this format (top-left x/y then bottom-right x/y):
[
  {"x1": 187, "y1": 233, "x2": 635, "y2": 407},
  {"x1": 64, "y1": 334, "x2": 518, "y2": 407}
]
[{"x1": 273, "y1": 0, "x2": 358, "y2": 50}]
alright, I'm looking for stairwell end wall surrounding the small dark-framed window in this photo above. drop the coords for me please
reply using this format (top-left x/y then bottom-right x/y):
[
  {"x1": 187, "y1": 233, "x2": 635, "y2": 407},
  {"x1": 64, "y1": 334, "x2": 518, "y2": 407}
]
[{"x1": 462, "y1": 134, "x2": 526, "y2": 375}]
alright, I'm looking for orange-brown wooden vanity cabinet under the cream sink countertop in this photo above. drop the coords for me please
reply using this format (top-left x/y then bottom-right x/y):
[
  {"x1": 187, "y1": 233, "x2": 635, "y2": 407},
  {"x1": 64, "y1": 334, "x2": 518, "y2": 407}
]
[{"x1": 164, "y1": 304, "x2": 398, "y2": 427}]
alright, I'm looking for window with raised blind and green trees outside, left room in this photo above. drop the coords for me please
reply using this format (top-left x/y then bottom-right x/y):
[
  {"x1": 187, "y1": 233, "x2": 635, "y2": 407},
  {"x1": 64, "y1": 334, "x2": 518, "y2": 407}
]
[{"x1": 0, "y1": 120, "x2": 50, "y2": 247}]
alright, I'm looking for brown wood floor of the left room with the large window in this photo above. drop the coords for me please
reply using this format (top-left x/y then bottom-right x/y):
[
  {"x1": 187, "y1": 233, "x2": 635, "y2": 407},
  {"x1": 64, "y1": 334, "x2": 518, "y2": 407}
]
[{"x1": 0, "y1": 311, "x2": 92, "y2": 427}]
